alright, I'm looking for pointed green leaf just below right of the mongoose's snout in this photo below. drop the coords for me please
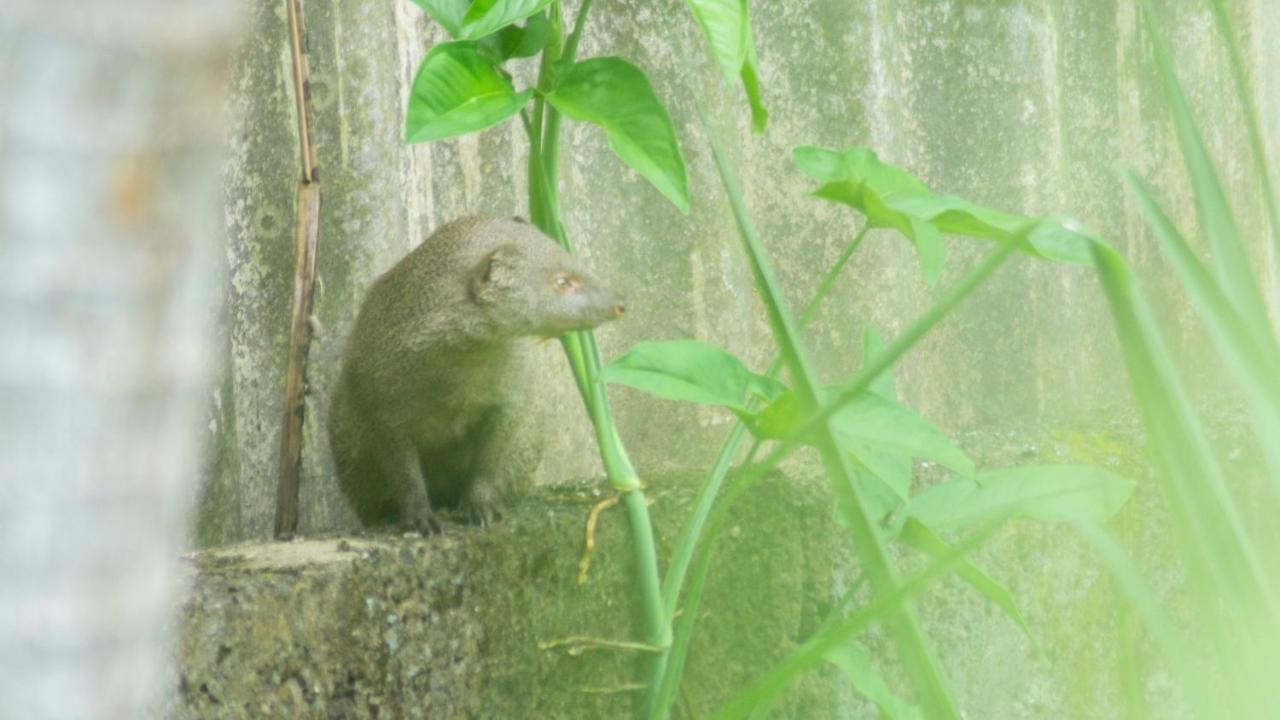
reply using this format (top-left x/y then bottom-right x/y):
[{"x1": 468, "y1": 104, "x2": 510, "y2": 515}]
[{"x1": 602, "y1": 340, "x2": 786, "y2": 414}]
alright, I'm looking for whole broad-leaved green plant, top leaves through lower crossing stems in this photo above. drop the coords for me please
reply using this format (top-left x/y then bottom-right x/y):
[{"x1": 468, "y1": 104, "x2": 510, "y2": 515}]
[{"x1": 406, "y1": 0, "x2": 1129, "y2": 717}]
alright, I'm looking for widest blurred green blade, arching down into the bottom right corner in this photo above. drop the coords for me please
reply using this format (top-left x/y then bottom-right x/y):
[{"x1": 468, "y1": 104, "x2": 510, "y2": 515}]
[{"x1": 1080, "y1": 242, "x2": 1280, "y2": 717}]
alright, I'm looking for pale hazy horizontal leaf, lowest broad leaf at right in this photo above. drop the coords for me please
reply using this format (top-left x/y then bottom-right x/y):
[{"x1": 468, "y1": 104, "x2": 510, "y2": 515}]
[{"x1": 908, "y1": 465, "x2": 1133, "y2": 530}]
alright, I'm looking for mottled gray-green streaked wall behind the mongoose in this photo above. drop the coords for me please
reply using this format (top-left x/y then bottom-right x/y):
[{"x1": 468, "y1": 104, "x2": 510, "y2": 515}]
[{"x1": 198, "y1": 0, "x2": 1280, "y2": 543}]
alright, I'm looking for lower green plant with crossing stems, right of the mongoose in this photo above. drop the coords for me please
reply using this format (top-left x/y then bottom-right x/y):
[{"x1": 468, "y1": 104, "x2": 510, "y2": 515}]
[{"x1": 605, "y1": 130, "x2": 1132, "y2": 717}]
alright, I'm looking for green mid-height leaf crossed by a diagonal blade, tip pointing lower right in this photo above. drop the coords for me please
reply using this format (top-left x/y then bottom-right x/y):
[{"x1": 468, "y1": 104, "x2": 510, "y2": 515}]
[{"x1": 754, "y1": 387, "x2": 974, "y2": 479}]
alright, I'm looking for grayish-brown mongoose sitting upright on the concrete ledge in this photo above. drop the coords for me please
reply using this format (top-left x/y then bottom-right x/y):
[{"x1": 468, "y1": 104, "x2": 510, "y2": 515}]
[{"x1": 329, "y1": 218, "x2": 623, "y2": 533}]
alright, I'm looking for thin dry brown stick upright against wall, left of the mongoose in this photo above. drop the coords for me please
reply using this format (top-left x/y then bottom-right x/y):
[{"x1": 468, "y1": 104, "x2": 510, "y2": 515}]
[{"x1": 275, "y1": 0, "x2": 320, "y2": 539}]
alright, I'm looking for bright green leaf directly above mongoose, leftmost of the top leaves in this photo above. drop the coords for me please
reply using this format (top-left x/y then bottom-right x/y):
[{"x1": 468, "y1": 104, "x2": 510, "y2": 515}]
[{"x1": 404, "y1": 41, "x2": 534, "y2": 142}]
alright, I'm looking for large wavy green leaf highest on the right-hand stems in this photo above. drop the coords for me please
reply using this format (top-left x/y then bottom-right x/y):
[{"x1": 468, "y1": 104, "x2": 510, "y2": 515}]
[{"x1": 794, "y1": 146, "x2": 1092, "y2": 271}]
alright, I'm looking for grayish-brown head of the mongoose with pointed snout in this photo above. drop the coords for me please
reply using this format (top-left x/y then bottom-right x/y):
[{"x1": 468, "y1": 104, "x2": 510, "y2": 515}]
[{"x1": 471, "y1": 223, "x2": 626, "y2": 337}]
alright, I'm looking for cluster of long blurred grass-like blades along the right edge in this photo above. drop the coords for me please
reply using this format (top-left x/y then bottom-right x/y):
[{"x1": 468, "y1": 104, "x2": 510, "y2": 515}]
[{"x1": 1070, "y1": 0, "x2": 1280, "y2": 717}]
